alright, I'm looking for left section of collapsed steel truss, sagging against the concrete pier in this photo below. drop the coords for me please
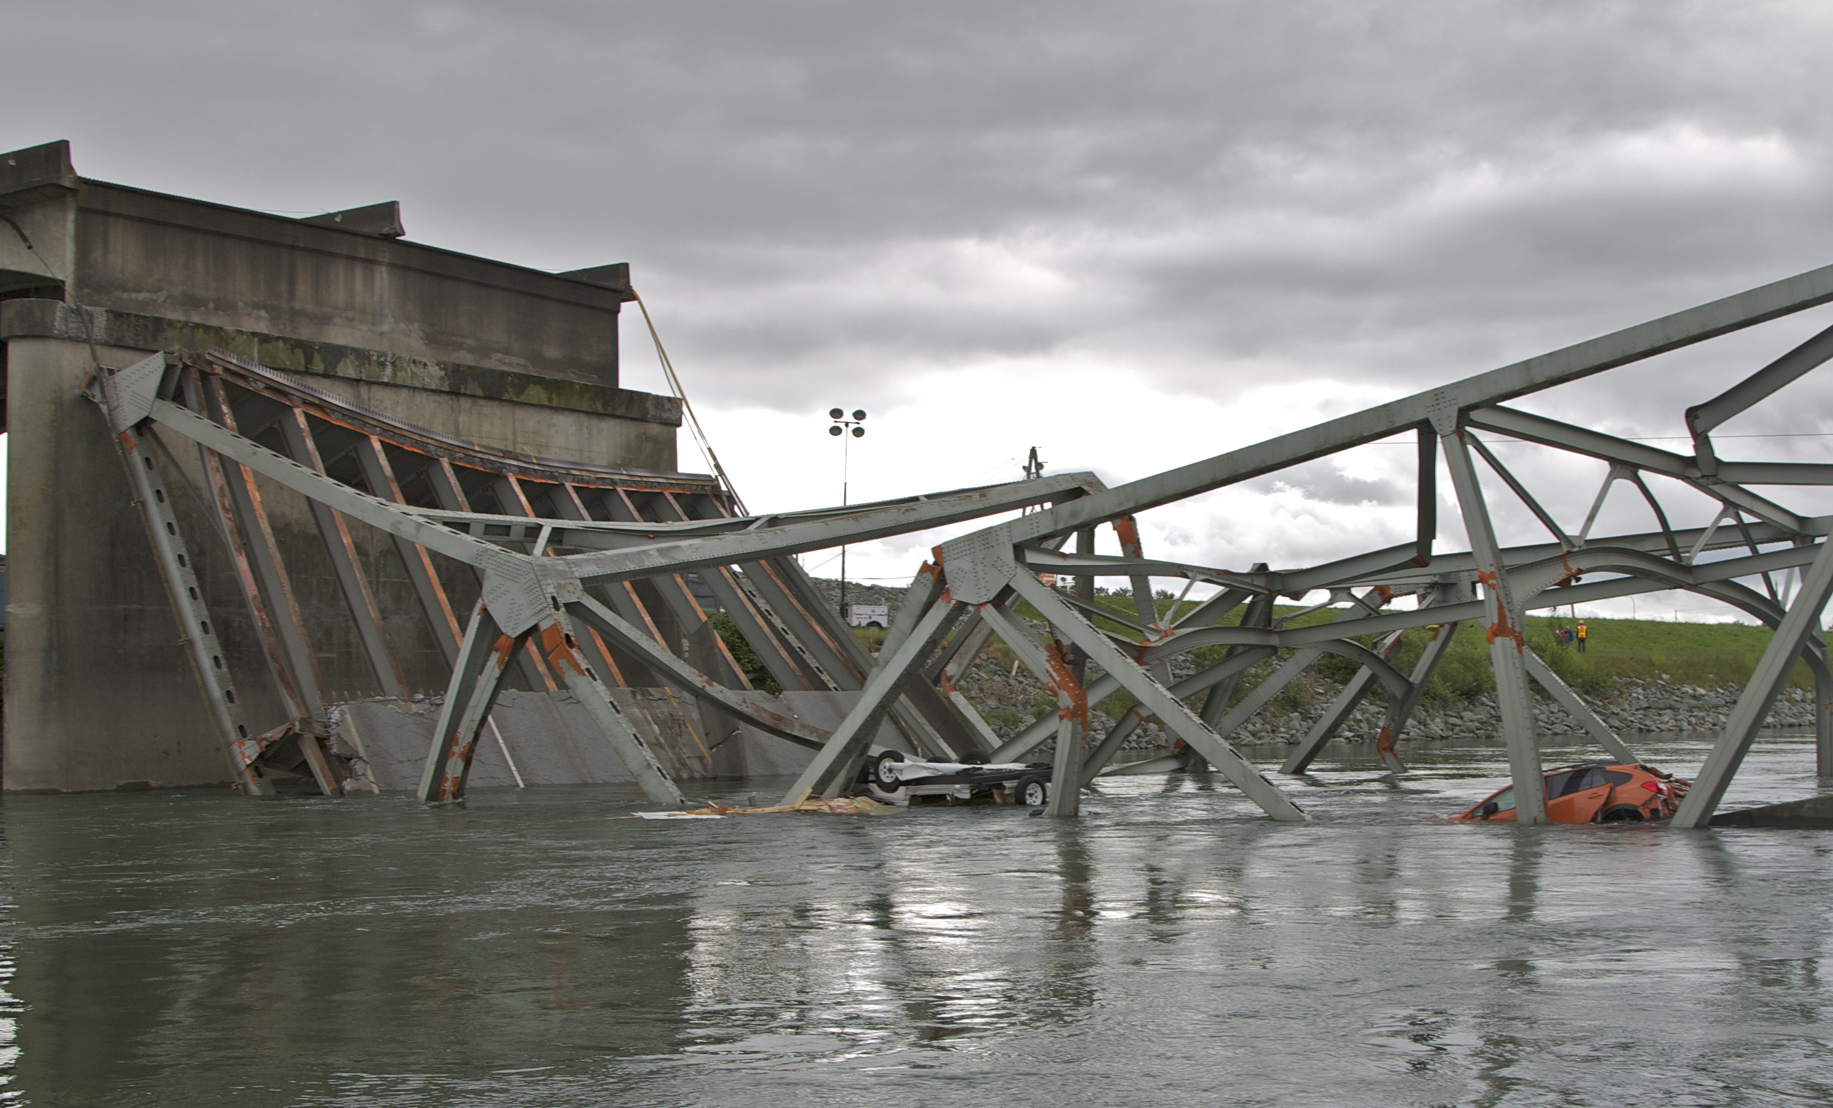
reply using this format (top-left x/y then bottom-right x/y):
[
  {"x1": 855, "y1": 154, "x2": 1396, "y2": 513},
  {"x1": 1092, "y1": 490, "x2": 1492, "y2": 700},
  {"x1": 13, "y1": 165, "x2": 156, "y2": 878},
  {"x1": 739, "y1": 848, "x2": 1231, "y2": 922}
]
[{"x1": 88, "y1": 354, "x2": 1100, "y2": 803}]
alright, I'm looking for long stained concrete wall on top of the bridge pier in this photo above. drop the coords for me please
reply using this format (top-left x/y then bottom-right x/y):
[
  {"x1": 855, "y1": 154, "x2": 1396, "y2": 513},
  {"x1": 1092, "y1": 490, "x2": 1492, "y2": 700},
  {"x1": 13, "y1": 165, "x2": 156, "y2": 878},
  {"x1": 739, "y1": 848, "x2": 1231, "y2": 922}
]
[{"x1": 0, "y1": 143, "x2": 629, "y2": 387}]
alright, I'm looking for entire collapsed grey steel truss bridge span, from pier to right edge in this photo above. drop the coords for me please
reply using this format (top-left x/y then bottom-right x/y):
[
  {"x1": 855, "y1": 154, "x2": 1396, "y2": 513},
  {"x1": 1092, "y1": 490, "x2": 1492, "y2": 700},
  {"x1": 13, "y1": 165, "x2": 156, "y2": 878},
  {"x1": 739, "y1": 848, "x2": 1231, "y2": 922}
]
[{"x1": 88, "y1": 268, "x2": 1833, "y2": 827}]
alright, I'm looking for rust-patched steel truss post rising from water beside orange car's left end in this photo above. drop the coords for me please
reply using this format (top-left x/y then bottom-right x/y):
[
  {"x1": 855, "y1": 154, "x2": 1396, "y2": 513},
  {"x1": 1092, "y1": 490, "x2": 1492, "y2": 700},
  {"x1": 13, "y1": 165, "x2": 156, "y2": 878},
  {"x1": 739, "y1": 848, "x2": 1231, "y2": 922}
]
[{"x1": 1432, "y1": 414, "x2": 1547, "y2": 824}]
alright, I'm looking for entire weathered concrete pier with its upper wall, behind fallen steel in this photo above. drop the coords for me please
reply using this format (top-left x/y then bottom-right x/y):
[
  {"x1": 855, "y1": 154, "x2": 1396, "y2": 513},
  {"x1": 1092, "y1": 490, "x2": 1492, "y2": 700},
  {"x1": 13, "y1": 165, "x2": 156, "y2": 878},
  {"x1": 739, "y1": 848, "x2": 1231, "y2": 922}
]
[{"x1": 0, "y1": 143, "x2": 680, "y2": 791}]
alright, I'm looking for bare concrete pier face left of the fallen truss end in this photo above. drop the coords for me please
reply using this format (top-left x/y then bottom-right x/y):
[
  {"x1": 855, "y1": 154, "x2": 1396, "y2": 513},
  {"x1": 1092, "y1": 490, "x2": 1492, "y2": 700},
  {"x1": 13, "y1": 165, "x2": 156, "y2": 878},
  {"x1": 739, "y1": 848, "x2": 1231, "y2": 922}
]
[{"x1": 5, "y1": 339, "x2": 245, "y2": 791}]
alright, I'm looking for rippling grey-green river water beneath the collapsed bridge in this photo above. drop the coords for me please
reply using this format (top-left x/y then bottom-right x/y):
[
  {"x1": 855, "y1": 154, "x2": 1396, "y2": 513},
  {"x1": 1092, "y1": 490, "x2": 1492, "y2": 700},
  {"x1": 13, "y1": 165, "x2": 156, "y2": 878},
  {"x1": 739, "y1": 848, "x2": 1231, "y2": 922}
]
[{"x1": 0, "y1": 734, "x2": 1833, "y2": 1108}]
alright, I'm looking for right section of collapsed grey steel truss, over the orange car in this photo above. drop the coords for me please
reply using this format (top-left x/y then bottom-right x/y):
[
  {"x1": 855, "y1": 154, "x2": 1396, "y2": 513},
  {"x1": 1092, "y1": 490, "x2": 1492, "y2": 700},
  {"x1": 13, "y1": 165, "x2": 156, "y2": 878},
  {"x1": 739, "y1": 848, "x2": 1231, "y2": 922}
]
[{"x1": 785, "y1": 268, "x2": 1833, "y2": 827}]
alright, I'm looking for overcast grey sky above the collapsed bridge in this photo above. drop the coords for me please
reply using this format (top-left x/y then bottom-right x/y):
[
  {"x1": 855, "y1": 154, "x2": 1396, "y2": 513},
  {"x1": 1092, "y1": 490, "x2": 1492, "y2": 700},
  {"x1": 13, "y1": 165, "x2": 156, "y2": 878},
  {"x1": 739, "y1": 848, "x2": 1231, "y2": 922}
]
[{"x1": 0, "y1": 0, "x2": 1833, "y2": 616}]
